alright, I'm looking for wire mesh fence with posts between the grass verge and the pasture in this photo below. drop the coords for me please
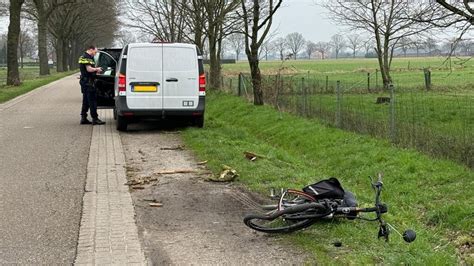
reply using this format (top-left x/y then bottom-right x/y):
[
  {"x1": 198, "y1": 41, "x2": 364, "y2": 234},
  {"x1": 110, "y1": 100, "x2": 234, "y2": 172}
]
[{"x1": 223, "y1": 74, "x2": 474, "y2": 168}]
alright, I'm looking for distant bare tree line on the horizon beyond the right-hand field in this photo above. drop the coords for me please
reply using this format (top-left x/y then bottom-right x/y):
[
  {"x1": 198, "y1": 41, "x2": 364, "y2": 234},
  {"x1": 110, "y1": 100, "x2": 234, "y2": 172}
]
[{"x1": 221, "y1": 32, "x2": 474, "y2": 60}]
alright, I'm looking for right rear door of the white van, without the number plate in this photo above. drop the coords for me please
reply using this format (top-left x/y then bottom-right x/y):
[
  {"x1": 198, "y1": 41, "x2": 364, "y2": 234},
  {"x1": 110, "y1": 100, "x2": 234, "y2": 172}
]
[{"x1": 163, "y1": 44, "x2": 199, "y2": 110}]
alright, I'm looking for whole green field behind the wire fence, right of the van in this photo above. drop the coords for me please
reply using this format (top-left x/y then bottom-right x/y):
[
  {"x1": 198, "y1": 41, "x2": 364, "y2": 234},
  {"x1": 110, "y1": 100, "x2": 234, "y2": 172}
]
[{"x1": 220, "y1": 58, "x2": 474, "y2": 167}]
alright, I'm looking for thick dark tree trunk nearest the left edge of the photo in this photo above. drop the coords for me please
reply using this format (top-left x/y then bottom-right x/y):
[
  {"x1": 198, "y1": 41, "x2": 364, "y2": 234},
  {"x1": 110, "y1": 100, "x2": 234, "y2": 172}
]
[{"x1": 7, "y1": 0, "x2": 24, "y2": 86}]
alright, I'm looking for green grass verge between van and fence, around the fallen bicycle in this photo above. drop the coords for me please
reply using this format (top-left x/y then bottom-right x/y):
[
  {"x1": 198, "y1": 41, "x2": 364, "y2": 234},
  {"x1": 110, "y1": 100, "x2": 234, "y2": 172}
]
[{"x1": 183, "y1": 93, "x2": 474, "y2": 265}]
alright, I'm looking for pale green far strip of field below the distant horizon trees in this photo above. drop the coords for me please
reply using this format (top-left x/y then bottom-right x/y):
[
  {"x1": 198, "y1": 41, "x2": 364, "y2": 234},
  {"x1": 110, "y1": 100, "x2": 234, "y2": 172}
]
[{"x1": 223, "y1": 57, "x2": 474, "y2": 89}]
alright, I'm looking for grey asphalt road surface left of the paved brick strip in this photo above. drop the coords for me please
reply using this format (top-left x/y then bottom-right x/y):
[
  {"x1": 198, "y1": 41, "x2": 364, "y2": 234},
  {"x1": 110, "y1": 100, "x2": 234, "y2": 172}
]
[{"x1": 0, "y1": 75, "x2": 92, "y2": 264}]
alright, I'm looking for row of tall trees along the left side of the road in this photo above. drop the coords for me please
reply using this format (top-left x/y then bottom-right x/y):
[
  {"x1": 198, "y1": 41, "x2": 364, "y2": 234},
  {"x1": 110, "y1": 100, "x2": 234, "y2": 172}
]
[{"x1": 0, "y1": 0, "x2": 119, "y2": 85}]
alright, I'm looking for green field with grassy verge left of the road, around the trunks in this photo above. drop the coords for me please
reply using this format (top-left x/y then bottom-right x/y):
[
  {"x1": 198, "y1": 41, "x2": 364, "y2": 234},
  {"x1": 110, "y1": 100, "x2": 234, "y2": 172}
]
[{"x1": 0, "y1": 67, "x2": 75, "y2": 103}]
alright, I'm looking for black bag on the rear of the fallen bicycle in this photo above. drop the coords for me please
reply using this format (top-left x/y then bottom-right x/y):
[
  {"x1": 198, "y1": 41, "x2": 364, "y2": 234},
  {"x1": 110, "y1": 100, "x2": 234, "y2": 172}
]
[{"x1": 303, "y1": 177, "x2": 344, "y2": 199}]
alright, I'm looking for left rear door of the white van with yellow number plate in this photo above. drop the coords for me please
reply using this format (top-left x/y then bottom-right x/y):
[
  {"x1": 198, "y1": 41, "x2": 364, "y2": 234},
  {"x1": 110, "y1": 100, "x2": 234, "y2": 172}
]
[{"x1": 126, "y1": 44, "x2": 164, "y2": 109}]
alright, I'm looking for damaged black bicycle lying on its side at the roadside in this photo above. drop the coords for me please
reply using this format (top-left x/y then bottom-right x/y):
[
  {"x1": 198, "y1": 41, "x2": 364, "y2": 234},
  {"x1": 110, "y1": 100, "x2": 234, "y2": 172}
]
[{"x1": 244, "y1": 174, "x2": 416, "y2": 243}]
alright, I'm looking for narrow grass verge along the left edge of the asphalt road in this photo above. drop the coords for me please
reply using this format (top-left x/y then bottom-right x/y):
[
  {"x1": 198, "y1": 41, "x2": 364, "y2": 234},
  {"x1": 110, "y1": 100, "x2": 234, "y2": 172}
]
[{"x1": 0, "y1": 71, "x2": 76, "y2": 103}]
